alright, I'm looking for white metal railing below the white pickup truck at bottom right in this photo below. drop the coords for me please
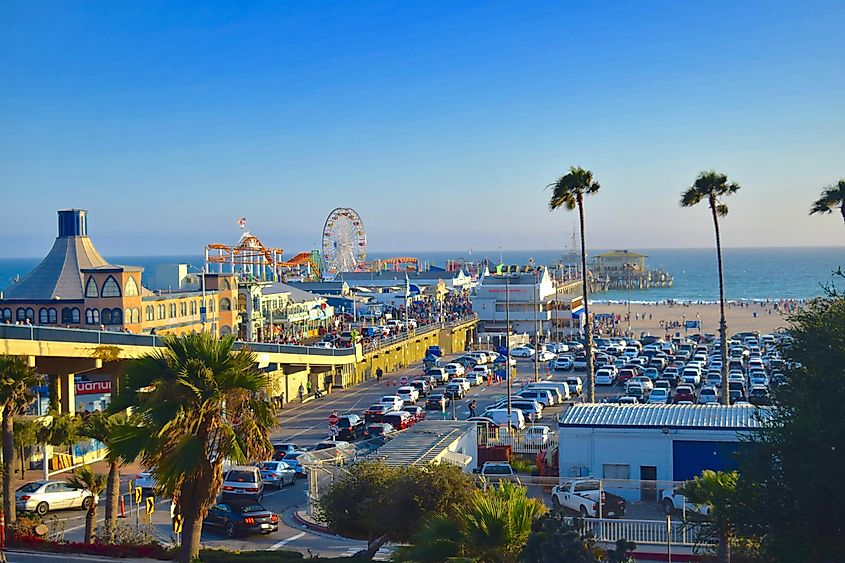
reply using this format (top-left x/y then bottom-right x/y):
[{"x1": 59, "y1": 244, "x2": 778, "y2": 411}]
[{"x1": 570, "y1": 518, "x2": 715, "y2": 546}]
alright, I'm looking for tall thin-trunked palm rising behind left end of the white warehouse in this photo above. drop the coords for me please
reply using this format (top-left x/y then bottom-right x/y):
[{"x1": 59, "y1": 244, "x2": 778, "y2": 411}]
[{"x1": 546, "y1": 166, "x2": 601, "y2": 403}]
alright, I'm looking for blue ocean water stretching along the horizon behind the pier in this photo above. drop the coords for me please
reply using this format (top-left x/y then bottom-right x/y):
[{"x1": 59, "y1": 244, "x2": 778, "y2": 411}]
[{"x1": 0, "y1": 247, "x2": 845, "y2": 302}]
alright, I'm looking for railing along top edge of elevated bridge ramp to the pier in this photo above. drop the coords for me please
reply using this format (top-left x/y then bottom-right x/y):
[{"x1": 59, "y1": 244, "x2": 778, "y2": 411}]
[{"x1": 0, "y1": 324, "x2": 355, "y2": 357}]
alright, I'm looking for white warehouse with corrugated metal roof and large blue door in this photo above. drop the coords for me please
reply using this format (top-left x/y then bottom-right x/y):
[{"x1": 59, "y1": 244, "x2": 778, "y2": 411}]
[{"x1": 558, "y1": 403, "x2": 771, "y2": 501}]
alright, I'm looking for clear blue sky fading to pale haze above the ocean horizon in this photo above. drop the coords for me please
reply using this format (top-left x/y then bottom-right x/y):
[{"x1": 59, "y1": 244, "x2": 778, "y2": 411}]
[{"x1": 0, "y1": 1, "x2": 845, "y2": 257}]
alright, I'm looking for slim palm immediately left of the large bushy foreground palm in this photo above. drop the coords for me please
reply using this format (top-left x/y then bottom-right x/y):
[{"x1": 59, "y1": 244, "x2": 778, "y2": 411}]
[{"x1": 79, "y1": 411, "x2": 137, "y2": 543}]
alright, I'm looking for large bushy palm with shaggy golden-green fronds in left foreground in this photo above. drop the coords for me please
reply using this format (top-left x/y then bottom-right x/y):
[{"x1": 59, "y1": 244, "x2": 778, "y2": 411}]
[{"x1": 112, "y1": 333, "x2": 275, "y2": 563}]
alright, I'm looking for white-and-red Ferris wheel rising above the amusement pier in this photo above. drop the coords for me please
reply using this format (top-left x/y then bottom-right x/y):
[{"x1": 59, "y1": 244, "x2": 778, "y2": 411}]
[{"x1": 323, "y1": 207, "x2": 367, "y2": 274}]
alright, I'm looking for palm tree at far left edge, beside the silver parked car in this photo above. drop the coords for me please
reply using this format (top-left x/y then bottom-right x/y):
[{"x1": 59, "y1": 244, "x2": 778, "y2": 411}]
[{"x1": 0, "y1": 354, "x2": 40, "y2": 533}]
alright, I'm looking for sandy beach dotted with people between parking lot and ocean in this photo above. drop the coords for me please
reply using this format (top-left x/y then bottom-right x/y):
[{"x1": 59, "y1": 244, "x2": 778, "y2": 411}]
[{"x1": 590, "y1": 303, "x2": 787, "y2": 336}]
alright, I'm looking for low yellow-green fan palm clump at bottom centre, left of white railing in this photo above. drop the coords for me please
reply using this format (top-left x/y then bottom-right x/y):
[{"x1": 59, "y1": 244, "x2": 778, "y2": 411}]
[{"x1": 397, "y1": 482, "x2": 547, "y2": 563}]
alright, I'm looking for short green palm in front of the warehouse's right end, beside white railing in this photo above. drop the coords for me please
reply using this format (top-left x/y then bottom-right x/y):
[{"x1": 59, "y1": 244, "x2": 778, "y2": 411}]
[{"x1": 678, "y1": 469, "x2": 739, "y2": 563}]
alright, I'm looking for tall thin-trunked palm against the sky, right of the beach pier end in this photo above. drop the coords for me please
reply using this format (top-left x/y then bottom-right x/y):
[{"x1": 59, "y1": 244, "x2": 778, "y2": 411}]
[{"x1": 681, "y1": 170, "x2": 739, "y2": 405}]
